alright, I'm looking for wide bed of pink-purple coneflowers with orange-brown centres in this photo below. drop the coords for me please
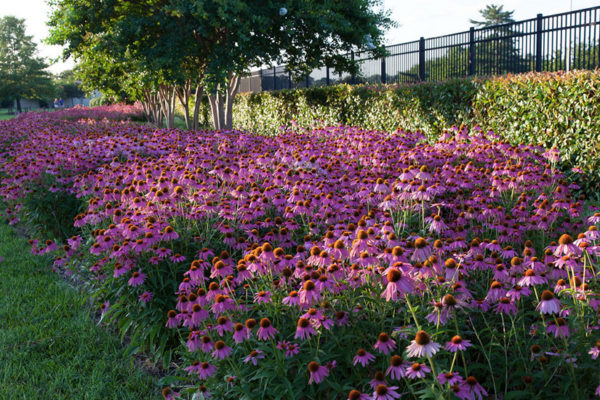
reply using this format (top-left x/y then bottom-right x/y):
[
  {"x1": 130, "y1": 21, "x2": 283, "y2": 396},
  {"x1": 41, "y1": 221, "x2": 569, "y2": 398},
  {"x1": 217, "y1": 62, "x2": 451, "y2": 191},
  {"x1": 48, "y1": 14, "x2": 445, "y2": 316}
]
[{"x1": 0, "y1": 107, "x2": 600, "y2": 400}]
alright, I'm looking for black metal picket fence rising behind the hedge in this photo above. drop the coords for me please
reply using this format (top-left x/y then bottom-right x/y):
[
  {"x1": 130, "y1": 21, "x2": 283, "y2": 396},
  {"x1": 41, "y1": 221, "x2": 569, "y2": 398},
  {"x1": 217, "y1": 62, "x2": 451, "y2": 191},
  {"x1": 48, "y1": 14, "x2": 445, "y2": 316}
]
[{"x1": 240, "y1": 6, "x2": 600, "y2": 92}]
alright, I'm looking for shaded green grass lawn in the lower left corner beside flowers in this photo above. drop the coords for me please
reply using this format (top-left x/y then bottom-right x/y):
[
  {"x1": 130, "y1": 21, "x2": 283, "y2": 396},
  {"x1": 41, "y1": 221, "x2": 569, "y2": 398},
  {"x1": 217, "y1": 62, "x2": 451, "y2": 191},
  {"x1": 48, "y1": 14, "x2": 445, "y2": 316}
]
[{"x1": 0, "y1": 220, "x2": 162, "y2": 400}]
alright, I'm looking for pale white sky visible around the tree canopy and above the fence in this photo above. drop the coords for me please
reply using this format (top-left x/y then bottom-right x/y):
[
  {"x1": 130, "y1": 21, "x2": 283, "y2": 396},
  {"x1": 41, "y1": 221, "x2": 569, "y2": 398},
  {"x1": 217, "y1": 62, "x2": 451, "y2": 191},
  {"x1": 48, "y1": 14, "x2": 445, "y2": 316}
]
[{"x1": 0, "y1": 0, "x2": 600, "y2": 73}]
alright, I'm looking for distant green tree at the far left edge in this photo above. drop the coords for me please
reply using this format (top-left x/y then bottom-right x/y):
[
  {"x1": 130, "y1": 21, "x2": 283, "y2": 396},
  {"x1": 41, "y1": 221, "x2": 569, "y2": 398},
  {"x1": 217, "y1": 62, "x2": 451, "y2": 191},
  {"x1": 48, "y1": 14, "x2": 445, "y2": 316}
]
[{"x1": 0, "y1": 16, "x2": 54, "y2": 112}]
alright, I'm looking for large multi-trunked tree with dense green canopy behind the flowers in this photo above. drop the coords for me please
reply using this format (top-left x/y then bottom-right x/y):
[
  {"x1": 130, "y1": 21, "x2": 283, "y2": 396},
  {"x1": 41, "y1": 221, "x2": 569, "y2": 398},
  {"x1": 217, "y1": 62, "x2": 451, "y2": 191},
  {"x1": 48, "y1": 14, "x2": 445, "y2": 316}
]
[{"x1": 49, "y1": 0, "x2": 391, "y2": 129}]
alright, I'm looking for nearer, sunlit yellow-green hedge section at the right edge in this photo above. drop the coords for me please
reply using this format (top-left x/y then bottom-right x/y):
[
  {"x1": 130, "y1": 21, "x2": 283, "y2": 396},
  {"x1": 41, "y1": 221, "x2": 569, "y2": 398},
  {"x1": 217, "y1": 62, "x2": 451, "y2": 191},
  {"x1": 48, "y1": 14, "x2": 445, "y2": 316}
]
[{"x1": 473, "y1": 70, "x2": 600, "y2": 193}]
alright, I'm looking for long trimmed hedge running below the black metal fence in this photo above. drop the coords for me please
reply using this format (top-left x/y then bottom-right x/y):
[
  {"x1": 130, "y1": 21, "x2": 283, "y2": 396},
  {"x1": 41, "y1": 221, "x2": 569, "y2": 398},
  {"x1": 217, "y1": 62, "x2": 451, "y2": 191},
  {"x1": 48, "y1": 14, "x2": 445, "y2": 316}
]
[{"x1": 205, "y1": 70, "x2": 600, "y2": 192}]
